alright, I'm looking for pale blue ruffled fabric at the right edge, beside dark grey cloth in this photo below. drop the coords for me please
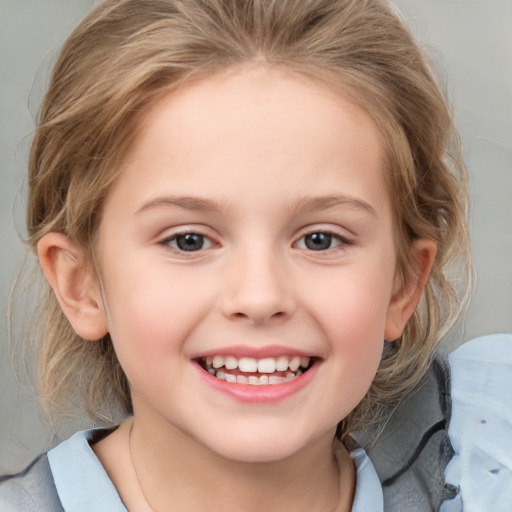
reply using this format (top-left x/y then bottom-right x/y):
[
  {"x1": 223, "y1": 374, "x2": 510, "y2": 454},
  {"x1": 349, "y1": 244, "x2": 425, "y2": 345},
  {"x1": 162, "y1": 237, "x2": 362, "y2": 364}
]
[{"x1": 440, "y1": 334, "x2": 512, "y2": 512}]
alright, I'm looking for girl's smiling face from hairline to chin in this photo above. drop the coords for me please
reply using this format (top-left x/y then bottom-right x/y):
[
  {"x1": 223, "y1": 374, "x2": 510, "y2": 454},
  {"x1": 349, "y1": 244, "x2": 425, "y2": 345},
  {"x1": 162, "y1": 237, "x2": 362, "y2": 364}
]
[{"x1": 99, "y1": 67, "x2": 414, "y2": 461}]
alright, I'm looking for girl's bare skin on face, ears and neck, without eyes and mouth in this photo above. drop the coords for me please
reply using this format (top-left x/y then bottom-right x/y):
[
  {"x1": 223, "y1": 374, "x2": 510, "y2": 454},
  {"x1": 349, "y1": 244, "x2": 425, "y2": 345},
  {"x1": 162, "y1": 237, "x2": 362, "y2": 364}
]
[{"x1": 39, "y1": 66, "x2": 435, "y2": 512}]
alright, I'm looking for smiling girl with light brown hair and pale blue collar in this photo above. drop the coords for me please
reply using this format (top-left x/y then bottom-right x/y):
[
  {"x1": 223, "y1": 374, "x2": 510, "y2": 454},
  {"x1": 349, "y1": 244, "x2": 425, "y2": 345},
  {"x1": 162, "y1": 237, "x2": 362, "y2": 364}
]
[{"x1": 0, "y1": 0, "x2": 510, "y2": 512}]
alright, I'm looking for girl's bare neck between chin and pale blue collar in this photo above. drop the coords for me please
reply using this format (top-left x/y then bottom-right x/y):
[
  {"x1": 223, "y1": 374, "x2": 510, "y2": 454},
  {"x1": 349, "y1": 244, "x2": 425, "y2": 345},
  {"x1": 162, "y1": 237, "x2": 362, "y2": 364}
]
[{"x1": 129, "y1": 414, "x2": 355, "y2": 512}]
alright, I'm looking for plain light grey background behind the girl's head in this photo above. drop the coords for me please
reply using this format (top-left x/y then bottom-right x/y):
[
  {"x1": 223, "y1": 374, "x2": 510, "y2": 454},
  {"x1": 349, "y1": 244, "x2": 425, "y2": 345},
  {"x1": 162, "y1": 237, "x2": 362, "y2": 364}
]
[{"x1": 0, "y1": 0, "x2": 512, "y2": 474}]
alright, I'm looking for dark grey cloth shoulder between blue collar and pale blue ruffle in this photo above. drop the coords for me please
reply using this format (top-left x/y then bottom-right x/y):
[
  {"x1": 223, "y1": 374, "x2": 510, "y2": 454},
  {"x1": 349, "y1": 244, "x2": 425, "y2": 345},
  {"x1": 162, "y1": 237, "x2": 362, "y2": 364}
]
[{"x1": 352, "y1": 357, "x2": 457, "y2": 512}]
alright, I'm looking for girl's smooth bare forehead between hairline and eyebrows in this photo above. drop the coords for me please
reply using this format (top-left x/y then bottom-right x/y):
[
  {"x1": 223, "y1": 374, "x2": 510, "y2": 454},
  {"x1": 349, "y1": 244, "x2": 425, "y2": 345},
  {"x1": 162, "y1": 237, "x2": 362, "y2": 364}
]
[{"x1": 106, "y1": 65, "x2": 386, "y2": 217}]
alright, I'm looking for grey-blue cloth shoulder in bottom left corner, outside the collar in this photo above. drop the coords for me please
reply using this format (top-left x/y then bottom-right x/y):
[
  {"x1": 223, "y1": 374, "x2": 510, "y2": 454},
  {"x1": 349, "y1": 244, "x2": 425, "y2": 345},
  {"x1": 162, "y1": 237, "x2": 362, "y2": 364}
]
[{"x1": 0, "y1": 454, "x2": 63, "y2": 512}]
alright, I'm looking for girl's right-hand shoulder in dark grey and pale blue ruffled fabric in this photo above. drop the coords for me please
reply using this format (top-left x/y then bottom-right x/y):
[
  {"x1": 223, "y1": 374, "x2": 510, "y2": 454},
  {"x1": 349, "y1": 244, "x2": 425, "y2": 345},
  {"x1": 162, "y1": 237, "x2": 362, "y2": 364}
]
[{"x1": 353, "y1": 334, "x2": 512, "y2": 512}]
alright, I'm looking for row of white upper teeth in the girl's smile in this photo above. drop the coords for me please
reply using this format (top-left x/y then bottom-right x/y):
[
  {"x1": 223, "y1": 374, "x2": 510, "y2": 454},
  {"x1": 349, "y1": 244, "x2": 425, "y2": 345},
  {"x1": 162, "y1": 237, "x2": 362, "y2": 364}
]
[{"x1": 206, "y1": 356, "x2": 310, "y2": 373}]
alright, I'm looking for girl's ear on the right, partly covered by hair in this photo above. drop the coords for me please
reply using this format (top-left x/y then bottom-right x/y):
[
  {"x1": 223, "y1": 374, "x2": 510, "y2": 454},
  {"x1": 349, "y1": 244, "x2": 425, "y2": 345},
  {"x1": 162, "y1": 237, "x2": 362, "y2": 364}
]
[{"x1": 384, "y1": 239, "x2": 437, "y2": 341}]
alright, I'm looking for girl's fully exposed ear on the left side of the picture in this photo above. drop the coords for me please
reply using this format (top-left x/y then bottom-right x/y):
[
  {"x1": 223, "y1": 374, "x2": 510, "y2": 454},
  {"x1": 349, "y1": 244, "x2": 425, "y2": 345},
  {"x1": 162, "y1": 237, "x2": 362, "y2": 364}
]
[{"x1": 37, "y1": 233, "x2": 108, "y2": 340}]
